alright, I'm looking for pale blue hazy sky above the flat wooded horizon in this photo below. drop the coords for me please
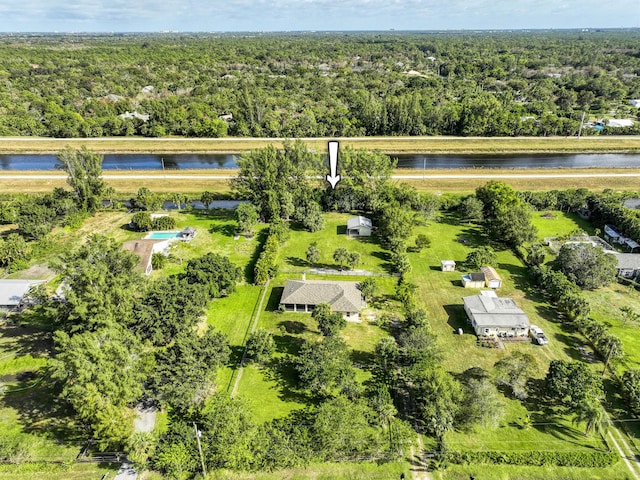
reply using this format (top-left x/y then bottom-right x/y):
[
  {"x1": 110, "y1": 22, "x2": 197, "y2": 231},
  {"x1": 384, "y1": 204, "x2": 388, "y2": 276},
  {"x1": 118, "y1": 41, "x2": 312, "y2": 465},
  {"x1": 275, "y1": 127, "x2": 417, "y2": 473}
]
[{"x1": 0, "y1": 0, "x2": 640, "y2": 32}]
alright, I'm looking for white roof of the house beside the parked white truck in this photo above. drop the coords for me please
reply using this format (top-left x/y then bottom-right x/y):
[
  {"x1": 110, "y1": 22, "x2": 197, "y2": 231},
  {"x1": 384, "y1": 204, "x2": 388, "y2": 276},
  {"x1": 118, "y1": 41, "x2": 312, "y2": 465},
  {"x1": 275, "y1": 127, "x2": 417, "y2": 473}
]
[{"x1": 462, "y1": 295, "x2": 529, "y2": 328}]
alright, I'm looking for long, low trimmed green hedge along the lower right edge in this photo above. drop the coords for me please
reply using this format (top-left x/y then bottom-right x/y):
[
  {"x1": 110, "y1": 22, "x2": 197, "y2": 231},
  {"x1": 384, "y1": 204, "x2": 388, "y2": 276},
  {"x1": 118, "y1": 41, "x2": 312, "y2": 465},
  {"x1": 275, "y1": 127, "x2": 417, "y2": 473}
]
[{"x1": 446, "y1": 450, "x2": 620, "y2": 468}]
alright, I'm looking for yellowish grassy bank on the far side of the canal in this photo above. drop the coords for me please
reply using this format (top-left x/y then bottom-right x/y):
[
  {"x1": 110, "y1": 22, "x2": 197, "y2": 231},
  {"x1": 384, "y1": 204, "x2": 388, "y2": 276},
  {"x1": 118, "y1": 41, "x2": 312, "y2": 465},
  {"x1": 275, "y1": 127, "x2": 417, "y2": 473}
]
[{"x1": 0, "y1": 136, "x2": 640, "y2": 154}]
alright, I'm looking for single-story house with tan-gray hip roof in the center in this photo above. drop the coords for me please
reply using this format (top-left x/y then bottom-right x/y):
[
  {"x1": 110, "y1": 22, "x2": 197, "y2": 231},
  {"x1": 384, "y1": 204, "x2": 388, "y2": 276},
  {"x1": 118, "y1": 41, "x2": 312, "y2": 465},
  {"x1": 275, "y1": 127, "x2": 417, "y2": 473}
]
[{"x1": 280, "y1": 280, "x2": 366, "y2": 321}]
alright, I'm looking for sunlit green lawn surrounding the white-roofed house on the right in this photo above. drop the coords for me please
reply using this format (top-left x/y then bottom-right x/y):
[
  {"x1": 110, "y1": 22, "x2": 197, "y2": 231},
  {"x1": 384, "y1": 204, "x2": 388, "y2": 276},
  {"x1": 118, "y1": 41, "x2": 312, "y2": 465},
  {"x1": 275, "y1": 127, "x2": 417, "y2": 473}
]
[{"x1": 409, "y1": 216, "x2": 579, "y2": 377}]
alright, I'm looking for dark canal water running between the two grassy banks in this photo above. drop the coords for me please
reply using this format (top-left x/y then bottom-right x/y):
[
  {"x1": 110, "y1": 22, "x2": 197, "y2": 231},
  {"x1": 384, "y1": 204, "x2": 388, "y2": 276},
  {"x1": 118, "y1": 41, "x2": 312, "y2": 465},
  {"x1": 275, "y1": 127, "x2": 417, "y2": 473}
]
[{"x1": 0, "y1": 154, "x2": 640, "y2": 170}]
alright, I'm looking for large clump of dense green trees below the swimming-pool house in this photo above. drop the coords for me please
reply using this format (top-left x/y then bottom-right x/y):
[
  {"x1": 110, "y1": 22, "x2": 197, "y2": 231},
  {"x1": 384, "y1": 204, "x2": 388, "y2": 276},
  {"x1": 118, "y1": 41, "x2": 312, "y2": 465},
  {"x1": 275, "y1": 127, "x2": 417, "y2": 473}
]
[{"x1": 37, "y1": 235, "x2": 240, "y2": 448}]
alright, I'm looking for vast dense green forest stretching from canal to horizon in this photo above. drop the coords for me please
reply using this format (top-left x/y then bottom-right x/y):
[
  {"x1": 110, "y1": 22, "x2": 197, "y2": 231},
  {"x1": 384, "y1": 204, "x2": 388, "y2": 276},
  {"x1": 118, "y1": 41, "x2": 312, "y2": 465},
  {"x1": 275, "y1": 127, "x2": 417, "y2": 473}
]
[{"x1": 0, "y1": 31, "x2": 640, "y2": 138}]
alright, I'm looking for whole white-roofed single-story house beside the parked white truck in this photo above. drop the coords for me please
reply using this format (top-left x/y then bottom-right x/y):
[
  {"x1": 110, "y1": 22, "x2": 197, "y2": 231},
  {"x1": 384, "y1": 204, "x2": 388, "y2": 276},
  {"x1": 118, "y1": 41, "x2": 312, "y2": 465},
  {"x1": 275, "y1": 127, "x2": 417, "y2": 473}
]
[{"x1": 462, "y1": 290, "x2": 529, "y2": 338}]
